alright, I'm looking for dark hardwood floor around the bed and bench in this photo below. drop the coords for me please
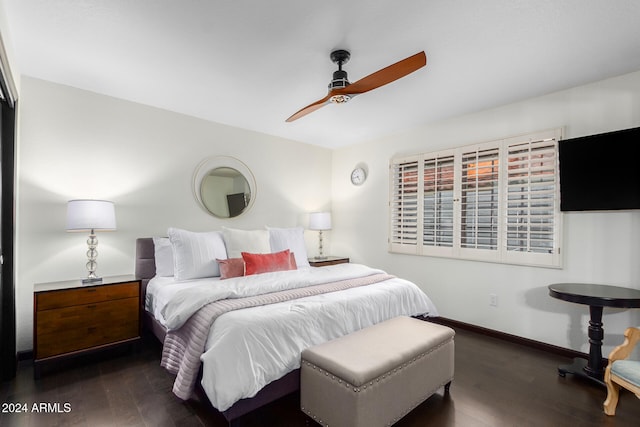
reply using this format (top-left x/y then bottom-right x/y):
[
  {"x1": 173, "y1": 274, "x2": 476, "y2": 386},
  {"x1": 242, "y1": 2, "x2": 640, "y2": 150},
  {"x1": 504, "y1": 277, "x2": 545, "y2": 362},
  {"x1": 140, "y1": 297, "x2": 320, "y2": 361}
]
[{"x1": 0, "y1": 329, "x2": 640, "y2": 427}]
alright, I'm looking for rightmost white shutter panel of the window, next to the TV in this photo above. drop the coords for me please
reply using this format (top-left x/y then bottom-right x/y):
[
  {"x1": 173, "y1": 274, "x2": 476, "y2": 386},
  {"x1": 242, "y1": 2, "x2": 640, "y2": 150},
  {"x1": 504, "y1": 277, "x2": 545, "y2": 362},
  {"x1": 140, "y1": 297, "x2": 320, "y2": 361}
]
[{"x1": 506, "y1": 138, "x2": 560, "y2": 264}]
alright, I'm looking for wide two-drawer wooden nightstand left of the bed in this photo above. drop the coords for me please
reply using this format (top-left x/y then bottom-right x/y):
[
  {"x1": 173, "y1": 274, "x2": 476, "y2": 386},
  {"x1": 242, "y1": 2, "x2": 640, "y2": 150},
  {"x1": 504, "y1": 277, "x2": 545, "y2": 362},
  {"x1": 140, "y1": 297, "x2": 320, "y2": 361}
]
[{"x1": 33, "y1": 276, "x2": 141, "y2": 378}]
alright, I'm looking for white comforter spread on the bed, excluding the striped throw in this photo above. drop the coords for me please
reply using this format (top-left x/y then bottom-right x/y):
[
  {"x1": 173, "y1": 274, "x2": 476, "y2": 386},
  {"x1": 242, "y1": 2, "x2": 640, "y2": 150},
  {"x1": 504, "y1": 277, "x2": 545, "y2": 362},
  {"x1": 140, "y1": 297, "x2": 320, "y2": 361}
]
[{"x1": 147, "y1": 264, "x2": 437, "y2": 411}]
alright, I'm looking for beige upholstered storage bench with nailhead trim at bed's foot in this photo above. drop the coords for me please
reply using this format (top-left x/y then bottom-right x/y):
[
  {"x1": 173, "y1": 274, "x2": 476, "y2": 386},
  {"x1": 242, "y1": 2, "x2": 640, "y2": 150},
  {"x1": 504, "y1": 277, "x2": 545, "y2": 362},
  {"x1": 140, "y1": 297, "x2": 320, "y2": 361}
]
[{"x1": 300, "y1": 317, "x2": 454, "y2": 427}]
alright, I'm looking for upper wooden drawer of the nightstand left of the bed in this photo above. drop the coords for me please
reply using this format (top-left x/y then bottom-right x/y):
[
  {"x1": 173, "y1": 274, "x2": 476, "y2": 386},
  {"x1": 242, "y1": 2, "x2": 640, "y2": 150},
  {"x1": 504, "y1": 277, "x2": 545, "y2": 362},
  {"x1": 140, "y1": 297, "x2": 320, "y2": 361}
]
[{"x1": 36, "y1": 282, "x2": 139, "y2": 311}]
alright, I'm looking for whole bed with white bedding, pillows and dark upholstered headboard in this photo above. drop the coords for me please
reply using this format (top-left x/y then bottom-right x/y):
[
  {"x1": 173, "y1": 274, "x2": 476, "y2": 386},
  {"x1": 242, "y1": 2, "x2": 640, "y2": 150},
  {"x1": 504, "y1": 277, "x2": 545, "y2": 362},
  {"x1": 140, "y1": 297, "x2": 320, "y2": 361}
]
[{"x1": 135, "y1": 228, "x2": 437, "y2": 423}]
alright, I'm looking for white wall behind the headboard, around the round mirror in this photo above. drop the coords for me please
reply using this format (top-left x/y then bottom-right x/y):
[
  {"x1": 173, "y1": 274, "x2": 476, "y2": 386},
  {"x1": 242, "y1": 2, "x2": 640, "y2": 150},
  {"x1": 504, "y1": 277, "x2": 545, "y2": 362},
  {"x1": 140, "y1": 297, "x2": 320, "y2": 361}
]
[{"x1": 16, "y1": 76, "x2": 331, "y2": 351}]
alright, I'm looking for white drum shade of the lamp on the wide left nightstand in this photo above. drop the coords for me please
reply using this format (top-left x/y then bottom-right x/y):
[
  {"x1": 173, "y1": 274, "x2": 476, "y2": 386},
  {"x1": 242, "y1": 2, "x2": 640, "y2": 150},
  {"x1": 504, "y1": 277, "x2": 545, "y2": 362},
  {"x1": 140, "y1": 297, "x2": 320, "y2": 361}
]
[{"x1": 67, "y1": 200, "x2": 116, "y2": 231}]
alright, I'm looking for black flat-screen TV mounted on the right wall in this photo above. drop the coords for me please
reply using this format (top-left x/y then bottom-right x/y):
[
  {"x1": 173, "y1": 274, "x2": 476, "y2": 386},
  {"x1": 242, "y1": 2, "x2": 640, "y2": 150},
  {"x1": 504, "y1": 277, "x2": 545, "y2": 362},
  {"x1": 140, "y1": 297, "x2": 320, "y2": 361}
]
[{"x1": 558, "y1": 128, "x2": 640, "y2": 211}]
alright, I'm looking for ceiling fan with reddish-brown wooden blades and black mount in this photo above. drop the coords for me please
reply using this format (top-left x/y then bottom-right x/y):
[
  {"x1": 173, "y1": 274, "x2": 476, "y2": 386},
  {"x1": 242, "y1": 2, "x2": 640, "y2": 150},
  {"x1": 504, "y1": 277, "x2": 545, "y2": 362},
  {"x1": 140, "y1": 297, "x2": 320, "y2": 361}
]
[{"x1": 286, "y1": 49, "x2": 427, "y2": 122}]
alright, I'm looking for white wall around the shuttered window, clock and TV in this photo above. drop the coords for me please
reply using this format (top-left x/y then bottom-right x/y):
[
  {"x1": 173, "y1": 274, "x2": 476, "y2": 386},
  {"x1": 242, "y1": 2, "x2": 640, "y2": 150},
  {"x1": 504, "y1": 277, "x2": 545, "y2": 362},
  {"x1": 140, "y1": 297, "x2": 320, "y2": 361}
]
[{"x1": 331, "y1": 72, "x2": 640, "y2": 356}]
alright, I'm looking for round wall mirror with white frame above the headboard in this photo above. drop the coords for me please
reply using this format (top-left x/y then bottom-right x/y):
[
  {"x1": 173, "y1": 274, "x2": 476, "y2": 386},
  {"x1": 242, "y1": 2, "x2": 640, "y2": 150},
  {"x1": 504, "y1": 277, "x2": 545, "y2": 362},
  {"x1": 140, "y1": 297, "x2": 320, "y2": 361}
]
[{"x1": 193, "y1": 156, "x2": 256, "y2": 218}]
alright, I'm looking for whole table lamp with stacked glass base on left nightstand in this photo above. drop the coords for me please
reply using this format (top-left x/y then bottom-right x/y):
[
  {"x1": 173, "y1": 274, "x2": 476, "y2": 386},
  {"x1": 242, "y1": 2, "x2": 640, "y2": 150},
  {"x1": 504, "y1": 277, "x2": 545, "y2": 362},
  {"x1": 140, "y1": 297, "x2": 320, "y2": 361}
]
[{"x1": 67, "y1": 200, "x2": 116, "y2": 283}]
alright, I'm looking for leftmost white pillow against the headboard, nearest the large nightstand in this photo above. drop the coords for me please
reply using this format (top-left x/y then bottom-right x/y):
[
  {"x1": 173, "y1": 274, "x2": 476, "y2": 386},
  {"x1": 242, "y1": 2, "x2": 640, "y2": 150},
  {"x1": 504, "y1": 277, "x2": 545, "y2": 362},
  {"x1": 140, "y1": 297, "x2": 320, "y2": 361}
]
[{"x1": 168, "y1": 228, "x2": 227, "y2": 280}]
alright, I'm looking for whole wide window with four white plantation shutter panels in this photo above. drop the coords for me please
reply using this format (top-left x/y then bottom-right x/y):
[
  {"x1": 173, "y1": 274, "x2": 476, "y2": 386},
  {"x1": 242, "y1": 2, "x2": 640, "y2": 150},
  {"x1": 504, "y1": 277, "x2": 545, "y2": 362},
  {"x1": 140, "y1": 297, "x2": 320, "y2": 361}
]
[{"x1": 389, "y1": 129, "x2": 561, "y2": 267}]
